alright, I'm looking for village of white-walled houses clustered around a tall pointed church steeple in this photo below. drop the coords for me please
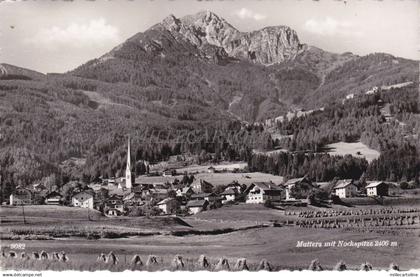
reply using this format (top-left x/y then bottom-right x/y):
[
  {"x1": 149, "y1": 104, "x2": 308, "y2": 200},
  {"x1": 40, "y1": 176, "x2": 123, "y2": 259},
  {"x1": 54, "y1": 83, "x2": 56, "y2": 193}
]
[{"x1": 7, "y1": 138, "x2": 415, "y2": 217}]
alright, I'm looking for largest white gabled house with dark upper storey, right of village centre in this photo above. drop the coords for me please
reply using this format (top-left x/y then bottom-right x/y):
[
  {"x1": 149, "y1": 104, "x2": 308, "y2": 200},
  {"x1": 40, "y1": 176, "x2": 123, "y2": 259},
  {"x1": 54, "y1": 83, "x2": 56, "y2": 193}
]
[{"x1": 245, "y1": 182, "x2": 283, "y2": 204}]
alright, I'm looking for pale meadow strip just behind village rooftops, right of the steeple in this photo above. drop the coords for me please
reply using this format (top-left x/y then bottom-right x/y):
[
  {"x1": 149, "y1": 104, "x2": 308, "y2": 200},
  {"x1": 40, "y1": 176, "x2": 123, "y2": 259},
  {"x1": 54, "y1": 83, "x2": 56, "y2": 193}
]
[{"x1": 136, "y1": 172, "x2": 283, "y2": 186}]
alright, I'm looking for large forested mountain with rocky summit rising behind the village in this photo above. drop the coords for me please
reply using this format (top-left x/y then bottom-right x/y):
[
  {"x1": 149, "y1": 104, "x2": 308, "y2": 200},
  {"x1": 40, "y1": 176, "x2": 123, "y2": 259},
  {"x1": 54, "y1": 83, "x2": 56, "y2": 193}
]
[{"x1": 0, "y1": 11, "x2": 419, "y2": 190}]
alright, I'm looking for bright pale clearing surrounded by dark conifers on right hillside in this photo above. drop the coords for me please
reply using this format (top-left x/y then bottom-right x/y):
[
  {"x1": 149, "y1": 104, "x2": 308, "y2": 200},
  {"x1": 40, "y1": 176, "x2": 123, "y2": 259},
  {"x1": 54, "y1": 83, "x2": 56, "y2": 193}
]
[{"x1": 326, "y1": 142, "x2": 380, "y2": 162}]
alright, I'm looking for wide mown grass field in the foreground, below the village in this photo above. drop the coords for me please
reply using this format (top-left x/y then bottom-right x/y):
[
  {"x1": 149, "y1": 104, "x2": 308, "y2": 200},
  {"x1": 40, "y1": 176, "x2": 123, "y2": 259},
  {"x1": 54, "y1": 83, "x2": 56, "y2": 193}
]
[{"x1": 0, "y1": 204, "x2": 420, "y2": 271}]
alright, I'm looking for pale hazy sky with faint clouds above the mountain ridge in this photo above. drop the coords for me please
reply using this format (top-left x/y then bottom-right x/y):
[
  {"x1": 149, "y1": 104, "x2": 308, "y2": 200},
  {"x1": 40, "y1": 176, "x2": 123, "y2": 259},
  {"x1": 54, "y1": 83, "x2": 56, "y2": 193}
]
[{"x1": 0, "y1": 0, "x2": 420, "y2": 72}]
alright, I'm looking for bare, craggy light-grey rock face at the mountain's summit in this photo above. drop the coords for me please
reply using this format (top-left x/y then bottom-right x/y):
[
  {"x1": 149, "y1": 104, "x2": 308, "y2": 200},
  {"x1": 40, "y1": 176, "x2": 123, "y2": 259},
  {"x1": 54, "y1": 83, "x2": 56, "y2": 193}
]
[{"x1": 151, "y1": 11, "x2": 303, "y2": 65}]
